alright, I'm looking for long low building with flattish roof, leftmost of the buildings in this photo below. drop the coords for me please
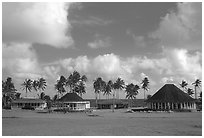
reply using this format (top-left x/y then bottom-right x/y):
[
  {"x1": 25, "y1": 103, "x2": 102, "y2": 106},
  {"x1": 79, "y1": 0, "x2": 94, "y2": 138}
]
[{"x1": 12, "y1": 98, "x2": 47, "y2": 108}]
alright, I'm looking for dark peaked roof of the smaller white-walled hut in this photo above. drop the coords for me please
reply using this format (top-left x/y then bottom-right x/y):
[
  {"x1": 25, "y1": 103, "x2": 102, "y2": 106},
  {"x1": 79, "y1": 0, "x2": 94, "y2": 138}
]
[{"x1": 58, "y1": 93, "x2": 84, "y2": 102}]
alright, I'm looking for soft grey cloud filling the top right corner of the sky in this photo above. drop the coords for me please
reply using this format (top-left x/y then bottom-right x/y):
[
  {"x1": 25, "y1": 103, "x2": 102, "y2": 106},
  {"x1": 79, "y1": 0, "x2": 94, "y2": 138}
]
[{"x1": 150, "y1": 2, "x2": 202, "y2": 49}]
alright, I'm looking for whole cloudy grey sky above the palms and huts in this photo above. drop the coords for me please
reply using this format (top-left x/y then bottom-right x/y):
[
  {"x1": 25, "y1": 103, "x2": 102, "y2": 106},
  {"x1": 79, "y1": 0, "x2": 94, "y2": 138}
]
[{"x1": 2, "y1": 2, "x2": 202, "y2": 99}]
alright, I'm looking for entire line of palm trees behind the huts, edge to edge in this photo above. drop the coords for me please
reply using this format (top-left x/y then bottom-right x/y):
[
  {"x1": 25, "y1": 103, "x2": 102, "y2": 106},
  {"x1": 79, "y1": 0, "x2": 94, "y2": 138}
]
[{"x1": 2, "y1": 71, "x2": 202, "y2": 108}]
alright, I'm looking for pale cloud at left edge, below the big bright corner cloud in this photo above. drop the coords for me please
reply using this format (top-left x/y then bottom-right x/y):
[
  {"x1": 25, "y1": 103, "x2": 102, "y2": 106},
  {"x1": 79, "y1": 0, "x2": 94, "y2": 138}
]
[{"x1": 2, "y1": 43, "x2": 41, "y2": 78}]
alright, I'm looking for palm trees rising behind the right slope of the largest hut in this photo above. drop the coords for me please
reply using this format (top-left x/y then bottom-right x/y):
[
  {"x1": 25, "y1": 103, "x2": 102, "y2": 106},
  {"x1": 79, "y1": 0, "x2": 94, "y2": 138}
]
[{"x1": 179, "y1": 79, "x2": 201, "y2": 99}]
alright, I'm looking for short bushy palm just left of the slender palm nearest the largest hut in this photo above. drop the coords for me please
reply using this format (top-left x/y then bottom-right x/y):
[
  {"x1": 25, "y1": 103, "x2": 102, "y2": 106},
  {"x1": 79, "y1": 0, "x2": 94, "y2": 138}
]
[{"x1": 125, "y1": 83, "x2": 140, "y2": 107}]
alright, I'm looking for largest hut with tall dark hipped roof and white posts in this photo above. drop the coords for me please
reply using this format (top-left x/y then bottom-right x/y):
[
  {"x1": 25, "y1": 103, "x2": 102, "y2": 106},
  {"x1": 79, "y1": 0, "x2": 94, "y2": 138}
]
[{"x1": 146, "y1": 84, "x2": 196, "y2": 110}]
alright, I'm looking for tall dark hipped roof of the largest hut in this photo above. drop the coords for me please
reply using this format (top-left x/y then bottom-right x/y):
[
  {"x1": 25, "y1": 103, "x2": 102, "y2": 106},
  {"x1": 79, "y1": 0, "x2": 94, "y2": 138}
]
[{"x1": 146, "y1": 84, "x2": 195, "y2": 102}]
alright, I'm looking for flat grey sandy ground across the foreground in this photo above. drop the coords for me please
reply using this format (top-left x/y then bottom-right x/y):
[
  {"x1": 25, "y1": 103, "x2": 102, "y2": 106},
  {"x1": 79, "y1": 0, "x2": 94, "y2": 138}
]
[{"x1": 2, "y1": 109, "x2": 202, "y2": 136}]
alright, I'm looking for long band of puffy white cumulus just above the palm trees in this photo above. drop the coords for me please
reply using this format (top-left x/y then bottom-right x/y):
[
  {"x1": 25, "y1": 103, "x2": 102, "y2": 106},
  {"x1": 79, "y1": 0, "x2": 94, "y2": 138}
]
[{"x1": 57, "y1": 49, "x2": 202, "y2": 85}]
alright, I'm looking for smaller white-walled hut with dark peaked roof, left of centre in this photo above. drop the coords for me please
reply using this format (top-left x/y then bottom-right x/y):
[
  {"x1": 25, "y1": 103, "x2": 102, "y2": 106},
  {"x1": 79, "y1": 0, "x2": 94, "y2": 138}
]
[{"x1": 53, "y1": 93, "x2": 90, "y2": 111}]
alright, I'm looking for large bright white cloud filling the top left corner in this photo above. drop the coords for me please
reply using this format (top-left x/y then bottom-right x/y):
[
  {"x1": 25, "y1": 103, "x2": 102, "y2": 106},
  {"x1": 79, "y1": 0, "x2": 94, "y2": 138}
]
[{"x1": 2, "y1": 2, "x2": 74, "y2": 48}]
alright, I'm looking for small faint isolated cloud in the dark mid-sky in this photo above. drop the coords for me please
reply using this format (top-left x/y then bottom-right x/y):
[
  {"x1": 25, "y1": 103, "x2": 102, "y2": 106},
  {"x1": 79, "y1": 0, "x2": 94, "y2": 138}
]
[{"x1": 88, "y1": 35, "x2": 112, "y2": 49}]
